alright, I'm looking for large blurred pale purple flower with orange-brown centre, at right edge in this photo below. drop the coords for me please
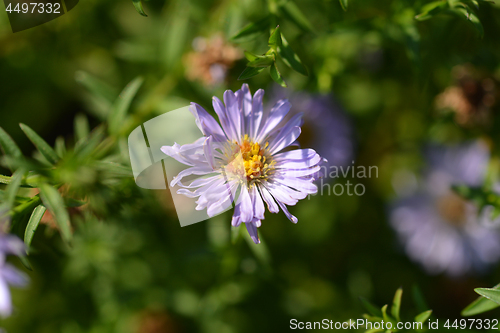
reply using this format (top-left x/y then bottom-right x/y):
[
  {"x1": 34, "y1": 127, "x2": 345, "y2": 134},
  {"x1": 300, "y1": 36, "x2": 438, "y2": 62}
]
[{"x1": 391, "y1": 142, "x2": 500, "y2": 276}]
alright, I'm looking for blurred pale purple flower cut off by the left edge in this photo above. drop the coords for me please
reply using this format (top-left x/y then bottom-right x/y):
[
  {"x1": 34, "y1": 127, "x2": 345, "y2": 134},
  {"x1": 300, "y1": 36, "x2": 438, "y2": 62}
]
[{"x1": 0, "y1": 212, "x2": 28, "y2": 318}]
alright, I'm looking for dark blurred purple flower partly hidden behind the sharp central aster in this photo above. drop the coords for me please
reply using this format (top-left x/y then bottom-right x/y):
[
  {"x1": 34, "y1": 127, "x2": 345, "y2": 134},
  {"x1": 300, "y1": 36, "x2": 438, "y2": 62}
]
[{"x1": 271, "y1": 87, "x2": 354, "y2": 176}]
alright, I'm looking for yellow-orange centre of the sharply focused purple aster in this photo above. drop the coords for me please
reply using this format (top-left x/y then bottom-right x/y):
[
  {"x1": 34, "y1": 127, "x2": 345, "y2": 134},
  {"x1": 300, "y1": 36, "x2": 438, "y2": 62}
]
[{"x1": 225, "y1": 134, "x2": 276, "y2": 184}]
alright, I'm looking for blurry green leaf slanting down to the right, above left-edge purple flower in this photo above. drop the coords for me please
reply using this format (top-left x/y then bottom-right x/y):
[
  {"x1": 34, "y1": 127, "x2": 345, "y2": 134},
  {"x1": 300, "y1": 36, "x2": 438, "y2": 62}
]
[{"x1": 39, "y1": 184, "x2": 72, "y2": 243}]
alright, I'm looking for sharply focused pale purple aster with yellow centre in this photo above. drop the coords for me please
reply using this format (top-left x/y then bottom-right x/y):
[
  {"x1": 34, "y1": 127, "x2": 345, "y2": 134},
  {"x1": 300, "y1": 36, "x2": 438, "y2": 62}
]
[{"x1": 161, "y1": 84, "x2": 322, "y2": 243}]
